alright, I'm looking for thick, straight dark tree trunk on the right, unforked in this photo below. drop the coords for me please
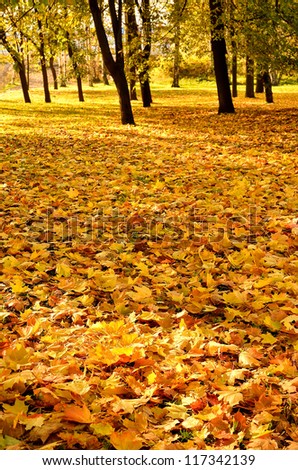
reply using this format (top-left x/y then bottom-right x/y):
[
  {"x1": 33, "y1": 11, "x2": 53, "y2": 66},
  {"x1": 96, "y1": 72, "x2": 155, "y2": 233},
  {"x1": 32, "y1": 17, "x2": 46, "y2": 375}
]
[{"x1": 209, "y1": 0, "x2": 235, "y2": 114}]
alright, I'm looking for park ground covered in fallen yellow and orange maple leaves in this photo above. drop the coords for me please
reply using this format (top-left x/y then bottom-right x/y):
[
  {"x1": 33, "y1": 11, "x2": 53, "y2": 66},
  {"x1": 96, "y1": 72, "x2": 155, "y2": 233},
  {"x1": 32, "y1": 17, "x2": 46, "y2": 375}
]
[{"x1": 0, "y1": 82, "x2": 298, "y2": 449}]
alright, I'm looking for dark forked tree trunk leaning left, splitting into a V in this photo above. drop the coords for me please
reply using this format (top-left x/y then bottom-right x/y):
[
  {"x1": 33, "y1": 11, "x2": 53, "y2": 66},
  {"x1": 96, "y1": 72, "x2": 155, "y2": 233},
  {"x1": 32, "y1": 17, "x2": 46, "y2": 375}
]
[{"x1": 89, "y1": 0, "x2": 135, "y2": 124}]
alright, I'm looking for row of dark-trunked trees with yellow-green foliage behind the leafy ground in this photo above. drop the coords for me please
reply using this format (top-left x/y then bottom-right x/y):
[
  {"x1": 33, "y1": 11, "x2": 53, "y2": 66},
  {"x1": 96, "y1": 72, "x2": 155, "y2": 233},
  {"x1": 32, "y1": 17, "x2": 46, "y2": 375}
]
[{"x1": 0, "y1": 0, "x2": 298, "y2": 119}]
